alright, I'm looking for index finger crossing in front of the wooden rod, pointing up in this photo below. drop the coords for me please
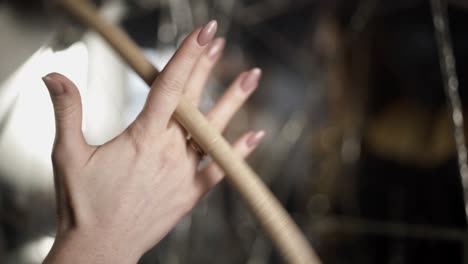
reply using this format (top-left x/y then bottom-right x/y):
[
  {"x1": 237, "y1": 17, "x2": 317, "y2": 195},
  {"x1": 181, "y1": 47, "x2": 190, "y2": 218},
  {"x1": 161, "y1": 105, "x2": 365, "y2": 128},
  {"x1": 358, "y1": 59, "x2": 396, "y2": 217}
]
[{"x1": 142, "y1": 21, "x2": 217, "y2": 131}]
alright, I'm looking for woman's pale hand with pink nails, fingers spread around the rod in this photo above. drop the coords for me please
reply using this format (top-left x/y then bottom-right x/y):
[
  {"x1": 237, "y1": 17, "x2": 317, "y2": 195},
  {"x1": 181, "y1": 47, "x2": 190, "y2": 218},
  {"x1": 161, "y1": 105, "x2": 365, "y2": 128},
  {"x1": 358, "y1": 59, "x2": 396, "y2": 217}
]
[{"x1": 44, "y1": 21, "x2": 264, "y2": 263}]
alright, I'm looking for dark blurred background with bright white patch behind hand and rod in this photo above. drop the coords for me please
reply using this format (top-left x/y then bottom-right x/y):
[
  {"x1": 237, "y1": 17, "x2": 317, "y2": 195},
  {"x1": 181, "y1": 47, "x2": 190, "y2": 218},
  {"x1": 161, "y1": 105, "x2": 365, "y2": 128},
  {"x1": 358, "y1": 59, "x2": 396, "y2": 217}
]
[{"x1": 0, "y1": 0, "x2": 468, "y2": 264}]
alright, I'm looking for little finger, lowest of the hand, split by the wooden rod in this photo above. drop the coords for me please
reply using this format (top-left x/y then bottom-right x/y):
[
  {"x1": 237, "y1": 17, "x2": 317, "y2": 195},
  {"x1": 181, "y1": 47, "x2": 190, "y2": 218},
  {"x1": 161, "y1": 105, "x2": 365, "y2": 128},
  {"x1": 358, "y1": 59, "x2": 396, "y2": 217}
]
[{"x1": 196, "y1": 130, "x2": 265, "y2": 194}]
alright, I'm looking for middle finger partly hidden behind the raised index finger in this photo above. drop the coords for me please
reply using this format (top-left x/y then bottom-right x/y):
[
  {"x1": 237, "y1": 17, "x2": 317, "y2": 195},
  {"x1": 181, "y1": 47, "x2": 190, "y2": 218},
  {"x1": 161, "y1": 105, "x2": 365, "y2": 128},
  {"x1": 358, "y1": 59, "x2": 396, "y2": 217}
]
[{"x1": 185, "y1": 38, "x2": 225, "y2": 105}]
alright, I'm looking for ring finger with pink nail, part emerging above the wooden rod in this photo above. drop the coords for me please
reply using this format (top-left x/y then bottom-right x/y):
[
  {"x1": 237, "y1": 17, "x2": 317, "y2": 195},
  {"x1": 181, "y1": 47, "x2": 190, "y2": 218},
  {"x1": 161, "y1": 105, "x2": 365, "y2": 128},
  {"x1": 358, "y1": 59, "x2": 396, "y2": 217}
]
[{"x1": 207, "y1": 68, "x2": 262, "y2": 131}]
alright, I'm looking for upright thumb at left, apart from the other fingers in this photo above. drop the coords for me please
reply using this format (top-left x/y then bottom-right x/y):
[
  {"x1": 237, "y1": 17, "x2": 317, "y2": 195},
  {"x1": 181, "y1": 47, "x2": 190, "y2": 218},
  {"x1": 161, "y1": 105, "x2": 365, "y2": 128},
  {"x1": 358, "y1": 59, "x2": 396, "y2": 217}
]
[{"x1": 42, "y1": 73, "x2": 85, "y2": 148}]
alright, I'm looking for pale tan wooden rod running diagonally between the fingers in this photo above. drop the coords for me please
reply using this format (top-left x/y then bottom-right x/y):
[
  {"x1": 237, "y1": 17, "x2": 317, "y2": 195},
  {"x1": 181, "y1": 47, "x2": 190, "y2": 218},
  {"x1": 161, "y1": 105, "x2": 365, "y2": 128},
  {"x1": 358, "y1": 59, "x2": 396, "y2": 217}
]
[{"x1": 58, "y1": 0, "x2": 320, "y2": 264}]
